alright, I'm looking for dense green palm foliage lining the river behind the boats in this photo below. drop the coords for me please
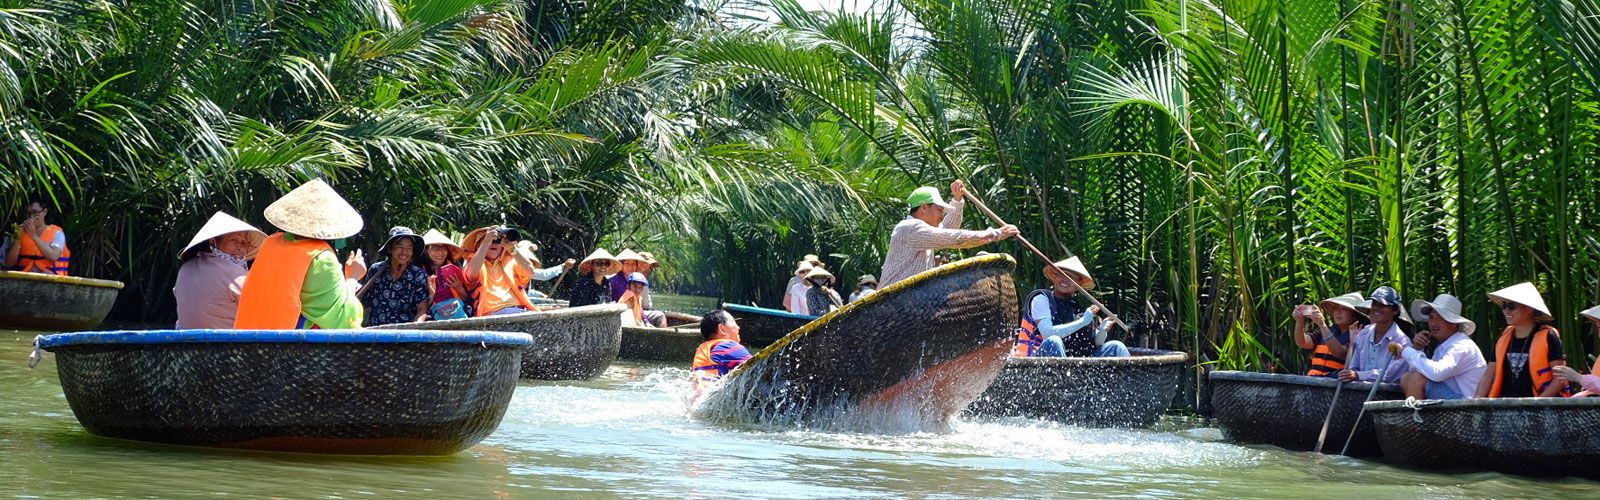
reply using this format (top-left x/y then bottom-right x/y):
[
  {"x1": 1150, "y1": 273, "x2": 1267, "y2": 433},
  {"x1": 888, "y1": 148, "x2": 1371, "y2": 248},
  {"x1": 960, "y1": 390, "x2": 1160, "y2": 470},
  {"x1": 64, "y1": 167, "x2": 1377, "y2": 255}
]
[{"x1": 0, "y1": 0, "x2": 1600, "y2": 376}]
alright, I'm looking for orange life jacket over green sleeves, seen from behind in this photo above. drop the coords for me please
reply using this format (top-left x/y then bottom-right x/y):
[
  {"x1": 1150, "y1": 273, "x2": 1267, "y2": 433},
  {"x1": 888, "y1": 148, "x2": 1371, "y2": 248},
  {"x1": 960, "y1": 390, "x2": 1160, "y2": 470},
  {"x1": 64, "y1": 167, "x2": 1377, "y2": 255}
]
[{"x1": 234, "y1": 232, "x2": 333, "y2": 330}]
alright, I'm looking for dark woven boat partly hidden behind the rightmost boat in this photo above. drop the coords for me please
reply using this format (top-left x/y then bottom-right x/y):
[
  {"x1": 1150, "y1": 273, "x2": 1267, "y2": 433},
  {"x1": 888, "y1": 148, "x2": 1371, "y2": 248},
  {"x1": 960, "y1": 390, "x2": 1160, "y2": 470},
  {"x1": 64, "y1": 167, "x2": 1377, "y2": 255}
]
[{"x1": 1210, "y1": 372, "x2": 1405, "y2": 457}]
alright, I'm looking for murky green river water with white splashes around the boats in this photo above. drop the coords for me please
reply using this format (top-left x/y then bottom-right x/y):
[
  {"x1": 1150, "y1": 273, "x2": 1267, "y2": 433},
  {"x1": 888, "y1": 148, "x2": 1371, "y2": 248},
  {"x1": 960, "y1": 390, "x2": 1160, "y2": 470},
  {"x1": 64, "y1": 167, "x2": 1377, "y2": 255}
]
[{"x1": 0, "y1": 330, "x2": 1600, "y2": 498}]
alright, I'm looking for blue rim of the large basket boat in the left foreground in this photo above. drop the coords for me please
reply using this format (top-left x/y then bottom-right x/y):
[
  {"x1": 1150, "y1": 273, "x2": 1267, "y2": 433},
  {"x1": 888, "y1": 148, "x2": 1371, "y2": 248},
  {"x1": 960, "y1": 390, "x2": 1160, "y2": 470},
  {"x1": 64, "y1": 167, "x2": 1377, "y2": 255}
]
[{"x1": 34, "y1": 330, "x2": 533, "y2": 349}]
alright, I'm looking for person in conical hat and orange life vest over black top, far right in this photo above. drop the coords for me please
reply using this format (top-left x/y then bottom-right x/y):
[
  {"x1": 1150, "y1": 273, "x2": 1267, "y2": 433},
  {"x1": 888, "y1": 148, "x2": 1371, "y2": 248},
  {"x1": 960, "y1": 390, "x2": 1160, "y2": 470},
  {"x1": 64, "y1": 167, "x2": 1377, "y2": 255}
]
[{"x1": 1477, "y1": 282, "x2": 1568, "y2": 397}]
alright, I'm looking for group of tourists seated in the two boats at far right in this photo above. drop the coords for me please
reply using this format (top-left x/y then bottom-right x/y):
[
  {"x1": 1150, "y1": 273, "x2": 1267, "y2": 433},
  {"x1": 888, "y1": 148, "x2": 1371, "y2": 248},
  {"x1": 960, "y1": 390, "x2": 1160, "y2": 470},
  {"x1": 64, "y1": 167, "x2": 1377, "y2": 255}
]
[{"x1": 1293, "y1": 282, "x2": 1600, "y2": 399}]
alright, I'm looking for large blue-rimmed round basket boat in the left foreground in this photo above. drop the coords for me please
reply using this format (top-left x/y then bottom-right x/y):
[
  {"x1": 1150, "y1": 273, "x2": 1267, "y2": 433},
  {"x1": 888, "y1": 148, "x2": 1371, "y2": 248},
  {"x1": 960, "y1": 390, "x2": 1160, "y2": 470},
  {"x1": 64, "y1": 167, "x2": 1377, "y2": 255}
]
[{"x1": 37, "y1": 330, "x2": 528, "y2": 455}]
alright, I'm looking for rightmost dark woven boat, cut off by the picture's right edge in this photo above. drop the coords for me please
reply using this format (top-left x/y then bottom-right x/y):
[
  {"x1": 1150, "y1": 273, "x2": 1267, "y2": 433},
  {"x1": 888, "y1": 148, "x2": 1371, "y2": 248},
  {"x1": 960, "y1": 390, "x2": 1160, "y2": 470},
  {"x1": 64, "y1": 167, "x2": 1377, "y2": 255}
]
[{"x1": 1366, "y1": 397, "x2": 1600, "y2": 479}]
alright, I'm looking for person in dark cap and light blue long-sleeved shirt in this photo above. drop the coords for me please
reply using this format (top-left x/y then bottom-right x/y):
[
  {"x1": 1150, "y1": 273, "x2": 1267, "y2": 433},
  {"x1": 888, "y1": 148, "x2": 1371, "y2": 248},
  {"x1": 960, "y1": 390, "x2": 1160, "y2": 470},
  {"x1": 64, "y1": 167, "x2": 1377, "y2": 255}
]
[{"x1": 1339, "y1": 287, "x2": 1408, "y2": 383}]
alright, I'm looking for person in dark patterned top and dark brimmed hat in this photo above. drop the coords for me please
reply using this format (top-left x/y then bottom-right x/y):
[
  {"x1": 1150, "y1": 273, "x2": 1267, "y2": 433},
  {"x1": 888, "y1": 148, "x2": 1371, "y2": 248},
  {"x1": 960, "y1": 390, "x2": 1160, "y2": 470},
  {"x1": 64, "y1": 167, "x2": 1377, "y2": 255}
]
[{"x1": 355, "y1": 226, "x2": 434, "y2": 327}]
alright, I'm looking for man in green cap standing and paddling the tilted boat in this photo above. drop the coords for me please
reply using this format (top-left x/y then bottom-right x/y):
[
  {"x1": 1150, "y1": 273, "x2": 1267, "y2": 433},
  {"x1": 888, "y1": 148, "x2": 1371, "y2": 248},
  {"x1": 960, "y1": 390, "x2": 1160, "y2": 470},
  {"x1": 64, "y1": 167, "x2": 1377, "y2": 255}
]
[{"x1": 878, "y1": 181, "x2": 1018, "y2": 287}]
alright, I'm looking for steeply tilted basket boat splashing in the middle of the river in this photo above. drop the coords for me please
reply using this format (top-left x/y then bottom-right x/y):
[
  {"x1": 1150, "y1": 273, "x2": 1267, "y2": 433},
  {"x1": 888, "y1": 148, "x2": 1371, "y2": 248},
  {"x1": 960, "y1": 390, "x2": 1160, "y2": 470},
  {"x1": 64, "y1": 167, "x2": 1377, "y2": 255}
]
[{"x1": 693, "y1": 255, "x2": 1018, "y2": 433}]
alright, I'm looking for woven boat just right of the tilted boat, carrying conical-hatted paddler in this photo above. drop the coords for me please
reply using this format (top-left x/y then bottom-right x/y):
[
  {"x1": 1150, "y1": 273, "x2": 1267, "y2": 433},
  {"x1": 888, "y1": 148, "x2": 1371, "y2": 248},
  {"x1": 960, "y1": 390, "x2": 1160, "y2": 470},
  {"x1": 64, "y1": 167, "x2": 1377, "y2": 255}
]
[{"x1": 966, "y1": 349, "x2": 1189, "y2": 428}]
